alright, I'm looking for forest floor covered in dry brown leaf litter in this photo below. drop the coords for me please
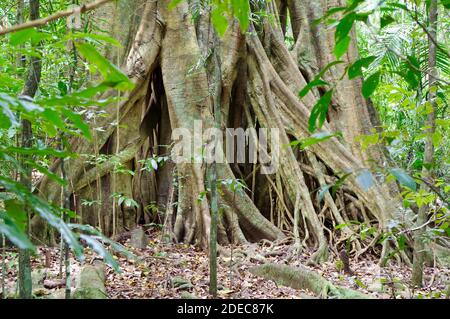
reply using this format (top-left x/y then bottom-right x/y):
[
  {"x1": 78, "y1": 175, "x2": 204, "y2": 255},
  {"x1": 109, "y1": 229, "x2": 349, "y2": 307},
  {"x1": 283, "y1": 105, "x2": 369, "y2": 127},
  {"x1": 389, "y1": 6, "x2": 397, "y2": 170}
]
[{"x1": 0, "y1": 231, "x2": 450, "y2": 299}]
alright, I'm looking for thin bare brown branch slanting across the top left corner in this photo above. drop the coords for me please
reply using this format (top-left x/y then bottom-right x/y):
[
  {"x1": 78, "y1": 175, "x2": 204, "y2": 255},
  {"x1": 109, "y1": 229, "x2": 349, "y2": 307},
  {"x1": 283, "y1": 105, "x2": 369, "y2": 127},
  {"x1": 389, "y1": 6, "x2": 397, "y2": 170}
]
[{"x1": 0, "y1": 0, "x2": 112, "y2": 35}]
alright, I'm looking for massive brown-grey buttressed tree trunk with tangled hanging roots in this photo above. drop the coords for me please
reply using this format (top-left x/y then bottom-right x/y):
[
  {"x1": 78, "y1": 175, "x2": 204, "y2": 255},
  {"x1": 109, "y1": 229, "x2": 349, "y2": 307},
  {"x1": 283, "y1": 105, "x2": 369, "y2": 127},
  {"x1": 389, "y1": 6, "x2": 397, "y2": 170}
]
[{"x1": 35, "y1": 0, "x2": 397, "y2": 262}]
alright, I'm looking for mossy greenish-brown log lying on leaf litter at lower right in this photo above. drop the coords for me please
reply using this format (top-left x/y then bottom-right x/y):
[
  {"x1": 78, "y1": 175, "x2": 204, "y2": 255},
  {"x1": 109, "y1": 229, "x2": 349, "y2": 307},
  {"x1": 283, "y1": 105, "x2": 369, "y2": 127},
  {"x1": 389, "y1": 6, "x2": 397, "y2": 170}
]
[{"x1": 249, "y1": 264, "x2": 371, "y2": 299}]
